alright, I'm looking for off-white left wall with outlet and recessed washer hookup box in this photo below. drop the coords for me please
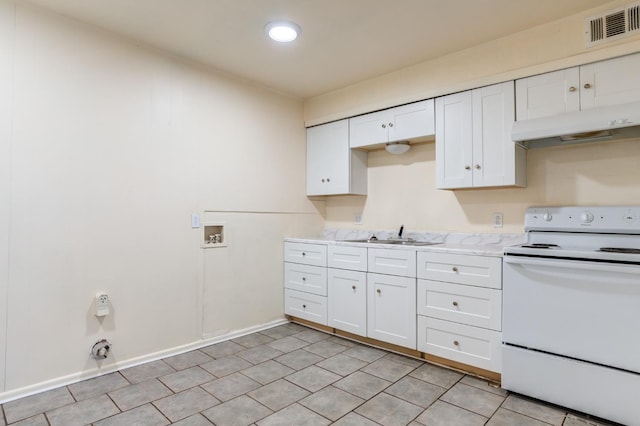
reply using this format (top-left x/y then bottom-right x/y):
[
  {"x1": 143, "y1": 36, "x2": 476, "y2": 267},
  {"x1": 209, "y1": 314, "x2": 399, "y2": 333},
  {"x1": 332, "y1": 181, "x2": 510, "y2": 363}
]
[{"x1": 0, "y1": 0, "x2": 322, "y2": 400}]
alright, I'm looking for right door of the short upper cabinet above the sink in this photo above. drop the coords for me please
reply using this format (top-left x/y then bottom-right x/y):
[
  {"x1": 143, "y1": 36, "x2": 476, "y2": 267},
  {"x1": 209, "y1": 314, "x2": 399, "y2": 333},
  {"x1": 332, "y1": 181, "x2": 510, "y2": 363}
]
[{"x1": 387, "y1": 99, "x2": 435, "y2": 142}]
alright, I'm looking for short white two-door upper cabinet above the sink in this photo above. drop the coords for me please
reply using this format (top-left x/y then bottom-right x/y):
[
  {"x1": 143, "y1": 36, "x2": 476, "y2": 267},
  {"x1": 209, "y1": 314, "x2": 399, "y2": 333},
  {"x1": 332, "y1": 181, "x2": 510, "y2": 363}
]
[{"x1": 349, "y1": 99, "x2": 434, "y2": 148}]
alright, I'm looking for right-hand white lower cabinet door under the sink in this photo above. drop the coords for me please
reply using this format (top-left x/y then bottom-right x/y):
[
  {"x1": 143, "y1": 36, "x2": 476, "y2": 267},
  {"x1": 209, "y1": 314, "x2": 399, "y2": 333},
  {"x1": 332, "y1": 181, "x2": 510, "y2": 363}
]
[{"x1": 367, "y1": 273, "x2": 416, "y2": 349}]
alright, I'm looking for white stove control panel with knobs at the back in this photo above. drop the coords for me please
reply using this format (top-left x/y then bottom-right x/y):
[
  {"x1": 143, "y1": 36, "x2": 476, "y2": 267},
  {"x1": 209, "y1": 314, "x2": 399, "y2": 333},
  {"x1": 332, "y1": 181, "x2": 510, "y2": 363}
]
[{"x1": 524, "y1": 206, "x2": 640, "y2": 234}]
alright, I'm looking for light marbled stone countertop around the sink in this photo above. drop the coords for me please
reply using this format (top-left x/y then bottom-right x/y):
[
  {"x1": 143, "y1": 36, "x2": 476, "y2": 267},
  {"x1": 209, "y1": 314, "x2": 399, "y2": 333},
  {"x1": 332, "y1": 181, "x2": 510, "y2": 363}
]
[{"x1": 285, "y1": 229, "x2": 526, "y2": 257}]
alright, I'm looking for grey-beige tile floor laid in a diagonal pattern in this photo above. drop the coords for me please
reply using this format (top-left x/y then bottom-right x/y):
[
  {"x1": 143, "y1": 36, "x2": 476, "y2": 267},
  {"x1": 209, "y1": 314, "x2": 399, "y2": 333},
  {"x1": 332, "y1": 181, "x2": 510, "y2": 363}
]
[{"x1": 0, "y1": 323, "x2": 620, "y2": 426}]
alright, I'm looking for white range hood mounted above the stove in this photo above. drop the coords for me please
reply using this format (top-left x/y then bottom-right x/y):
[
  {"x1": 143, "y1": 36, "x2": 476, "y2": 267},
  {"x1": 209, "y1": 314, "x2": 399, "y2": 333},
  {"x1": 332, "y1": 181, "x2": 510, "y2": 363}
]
[{"x1": 511, "y1": 102, "x2": 640, "y2": 148}]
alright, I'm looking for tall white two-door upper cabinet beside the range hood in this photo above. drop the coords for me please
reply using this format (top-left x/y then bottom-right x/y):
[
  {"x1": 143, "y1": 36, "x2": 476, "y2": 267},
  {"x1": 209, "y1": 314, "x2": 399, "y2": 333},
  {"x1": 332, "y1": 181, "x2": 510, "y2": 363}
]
[{"x1": 436, "y1": 81, "x2": 526, "y2": 189}]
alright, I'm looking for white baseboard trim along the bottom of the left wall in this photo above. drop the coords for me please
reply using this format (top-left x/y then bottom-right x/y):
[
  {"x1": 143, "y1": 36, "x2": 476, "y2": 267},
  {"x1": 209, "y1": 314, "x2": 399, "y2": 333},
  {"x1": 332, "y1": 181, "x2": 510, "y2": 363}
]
[{"x1": 0, "y1": 318, "x2": 289, "y2": 403}]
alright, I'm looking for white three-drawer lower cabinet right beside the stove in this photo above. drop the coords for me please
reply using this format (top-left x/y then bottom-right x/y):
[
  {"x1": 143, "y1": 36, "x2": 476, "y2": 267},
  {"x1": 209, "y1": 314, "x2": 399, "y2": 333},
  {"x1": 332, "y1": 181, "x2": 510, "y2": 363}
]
[{"x1": 417, "y1": 252, "x2": 502, "y2": 373}]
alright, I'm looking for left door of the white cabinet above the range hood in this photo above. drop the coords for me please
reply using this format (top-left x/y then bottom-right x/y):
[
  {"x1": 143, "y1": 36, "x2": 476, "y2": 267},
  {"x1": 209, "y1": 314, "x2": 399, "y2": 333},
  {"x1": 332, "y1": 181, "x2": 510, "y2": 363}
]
[{"x1": 516, "y1": 67, "x2": 580, "y2": 121}]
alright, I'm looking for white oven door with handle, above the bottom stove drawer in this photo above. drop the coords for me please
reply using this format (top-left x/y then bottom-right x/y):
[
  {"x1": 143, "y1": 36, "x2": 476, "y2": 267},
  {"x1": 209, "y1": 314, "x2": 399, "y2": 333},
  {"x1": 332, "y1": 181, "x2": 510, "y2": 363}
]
[{"x1": 502, "y1": 256, "x2": 640, "y2": 373}]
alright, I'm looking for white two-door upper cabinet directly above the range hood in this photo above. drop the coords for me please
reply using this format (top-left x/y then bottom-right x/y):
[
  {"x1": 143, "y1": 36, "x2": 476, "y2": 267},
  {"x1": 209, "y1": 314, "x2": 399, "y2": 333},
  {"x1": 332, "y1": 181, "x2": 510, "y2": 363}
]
[{"x1": 516, "y1": 53, "x2": 640, "y2": 121}]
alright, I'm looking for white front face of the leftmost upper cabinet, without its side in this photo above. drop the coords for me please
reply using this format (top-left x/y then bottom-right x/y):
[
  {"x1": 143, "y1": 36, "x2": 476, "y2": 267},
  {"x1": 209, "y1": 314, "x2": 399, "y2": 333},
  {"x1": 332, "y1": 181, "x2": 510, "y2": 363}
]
[{"x1": 307, "y1": 119, "x2": 351, "y2": 195}]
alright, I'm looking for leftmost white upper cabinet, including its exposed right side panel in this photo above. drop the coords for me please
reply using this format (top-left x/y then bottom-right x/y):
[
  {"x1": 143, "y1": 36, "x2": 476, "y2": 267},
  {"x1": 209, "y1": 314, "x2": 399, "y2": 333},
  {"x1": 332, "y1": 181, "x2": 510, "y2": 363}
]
[{"x1": 307, "y1": 119, "x2": 367, "y2": 195}]
